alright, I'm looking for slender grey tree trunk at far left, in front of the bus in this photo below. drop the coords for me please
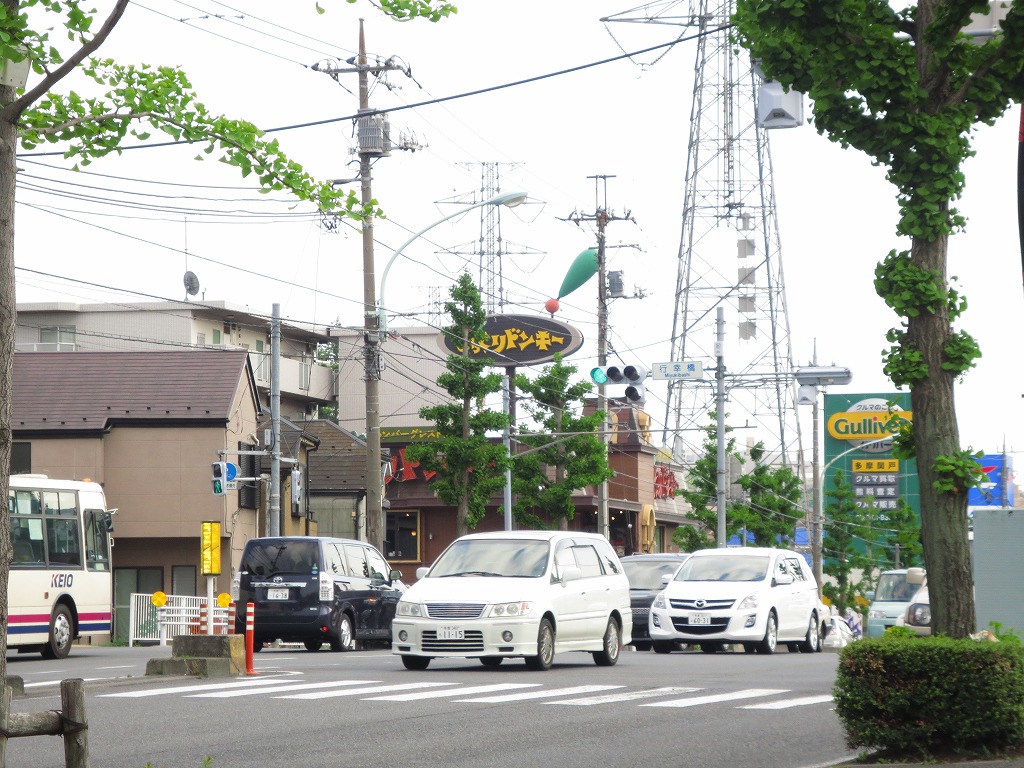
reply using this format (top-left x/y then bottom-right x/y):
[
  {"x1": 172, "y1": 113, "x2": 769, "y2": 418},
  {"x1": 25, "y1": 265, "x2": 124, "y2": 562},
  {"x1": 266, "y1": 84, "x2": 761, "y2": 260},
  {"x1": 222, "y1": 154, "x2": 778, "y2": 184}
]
[{"x1": 0, "y1": 66, "x2": 17, "y2": 681}]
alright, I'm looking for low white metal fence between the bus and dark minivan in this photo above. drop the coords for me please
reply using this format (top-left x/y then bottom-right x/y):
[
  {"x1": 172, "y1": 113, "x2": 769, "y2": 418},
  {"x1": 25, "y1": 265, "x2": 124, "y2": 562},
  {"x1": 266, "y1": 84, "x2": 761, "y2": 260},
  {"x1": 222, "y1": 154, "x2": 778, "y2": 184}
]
[{"x1": 128, "y1": 593, "x2": 234, "y2": 647}]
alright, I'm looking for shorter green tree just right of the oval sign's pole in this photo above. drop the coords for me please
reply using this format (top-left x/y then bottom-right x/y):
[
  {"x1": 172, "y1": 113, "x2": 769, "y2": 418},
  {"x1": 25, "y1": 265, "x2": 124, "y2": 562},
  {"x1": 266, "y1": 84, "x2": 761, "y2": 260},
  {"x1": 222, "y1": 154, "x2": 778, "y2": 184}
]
[{"x1": 512, "y1": 354, "x2": 612, "y2": 527}]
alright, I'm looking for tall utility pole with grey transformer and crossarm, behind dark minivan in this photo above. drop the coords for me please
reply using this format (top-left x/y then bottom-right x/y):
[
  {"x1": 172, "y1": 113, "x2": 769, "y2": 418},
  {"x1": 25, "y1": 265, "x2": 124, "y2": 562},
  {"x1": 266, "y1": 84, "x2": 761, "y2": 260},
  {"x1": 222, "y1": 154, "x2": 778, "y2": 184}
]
[{"x1": 313, "y1": 18, "x2": 408, "y2": 551}]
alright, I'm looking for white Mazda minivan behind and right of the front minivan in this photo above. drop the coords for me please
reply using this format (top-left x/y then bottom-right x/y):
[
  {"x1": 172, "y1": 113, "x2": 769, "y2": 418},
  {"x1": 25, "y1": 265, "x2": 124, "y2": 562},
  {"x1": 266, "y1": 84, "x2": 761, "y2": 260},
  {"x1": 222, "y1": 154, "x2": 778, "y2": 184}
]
[{"x1": 648, "y1": 547, "x2": 828, "y2": 653}]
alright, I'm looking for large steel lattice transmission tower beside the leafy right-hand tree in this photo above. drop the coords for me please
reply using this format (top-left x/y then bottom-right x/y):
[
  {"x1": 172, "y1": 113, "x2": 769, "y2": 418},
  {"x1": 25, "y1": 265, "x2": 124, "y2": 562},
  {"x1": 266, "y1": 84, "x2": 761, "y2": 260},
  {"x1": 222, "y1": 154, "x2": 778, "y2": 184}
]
[{"x1": 602, "y1": 0, "x2": 802, "y2": 464}]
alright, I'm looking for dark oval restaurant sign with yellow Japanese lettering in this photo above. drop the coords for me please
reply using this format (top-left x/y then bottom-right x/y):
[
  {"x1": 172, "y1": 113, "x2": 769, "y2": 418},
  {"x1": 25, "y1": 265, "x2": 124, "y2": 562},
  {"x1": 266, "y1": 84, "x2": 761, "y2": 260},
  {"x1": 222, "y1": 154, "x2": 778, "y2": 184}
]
[{"x1": 438, "y1": 314, "x2": 583, "y2": 368}]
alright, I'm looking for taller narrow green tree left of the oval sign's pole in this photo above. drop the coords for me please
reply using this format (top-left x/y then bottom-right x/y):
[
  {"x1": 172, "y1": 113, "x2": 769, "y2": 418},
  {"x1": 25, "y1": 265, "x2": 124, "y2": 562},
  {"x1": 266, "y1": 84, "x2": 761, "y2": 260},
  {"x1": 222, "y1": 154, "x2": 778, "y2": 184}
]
[{"x1": 406, "y1": 272, "x2": 509, "y2": 536}]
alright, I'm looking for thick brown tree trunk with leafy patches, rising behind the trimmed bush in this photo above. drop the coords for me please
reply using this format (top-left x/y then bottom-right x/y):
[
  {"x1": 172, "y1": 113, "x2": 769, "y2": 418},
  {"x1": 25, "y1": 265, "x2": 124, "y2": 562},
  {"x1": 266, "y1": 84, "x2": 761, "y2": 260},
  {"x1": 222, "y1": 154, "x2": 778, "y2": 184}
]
[{"x1": 906, "y1": 238, "x2": 976, "y2": 638}]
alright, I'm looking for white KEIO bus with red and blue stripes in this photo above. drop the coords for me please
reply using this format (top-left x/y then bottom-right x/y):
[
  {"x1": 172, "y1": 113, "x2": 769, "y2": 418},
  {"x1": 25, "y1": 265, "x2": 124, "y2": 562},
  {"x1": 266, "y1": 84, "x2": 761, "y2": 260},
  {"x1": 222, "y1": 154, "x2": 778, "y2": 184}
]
[{"x1": 7, "y1": 474, "x2": 114, "y2": 658}]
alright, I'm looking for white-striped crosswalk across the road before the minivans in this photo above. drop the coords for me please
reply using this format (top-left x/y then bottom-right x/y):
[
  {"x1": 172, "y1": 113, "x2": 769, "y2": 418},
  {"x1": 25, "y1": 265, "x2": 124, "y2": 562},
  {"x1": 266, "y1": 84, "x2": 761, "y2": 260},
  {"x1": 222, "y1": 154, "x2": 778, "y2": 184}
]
[{"x1": 98, "y1": 675, "x2": 833, "y2": 711}]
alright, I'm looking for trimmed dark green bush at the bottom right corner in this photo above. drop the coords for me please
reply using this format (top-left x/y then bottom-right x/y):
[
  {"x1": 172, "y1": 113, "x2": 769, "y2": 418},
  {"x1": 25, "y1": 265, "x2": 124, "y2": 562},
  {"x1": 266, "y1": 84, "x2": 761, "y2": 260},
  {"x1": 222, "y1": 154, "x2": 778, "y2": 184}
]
[{"x1": 833, "y1": 632, "x2": 1024, "y2": 758}]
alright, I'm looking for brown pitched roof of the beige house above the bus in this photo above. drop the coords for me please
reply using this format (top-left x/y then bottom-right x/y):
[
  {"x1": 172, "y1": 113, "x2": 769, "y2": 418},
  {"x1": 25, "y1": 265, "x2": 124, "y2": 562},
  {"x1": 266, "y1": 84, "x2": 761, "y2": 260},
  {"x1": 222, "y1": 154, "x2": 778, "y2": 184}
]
[{"x1": 11, "y1": 349, "x2": 258, "y2": 434}]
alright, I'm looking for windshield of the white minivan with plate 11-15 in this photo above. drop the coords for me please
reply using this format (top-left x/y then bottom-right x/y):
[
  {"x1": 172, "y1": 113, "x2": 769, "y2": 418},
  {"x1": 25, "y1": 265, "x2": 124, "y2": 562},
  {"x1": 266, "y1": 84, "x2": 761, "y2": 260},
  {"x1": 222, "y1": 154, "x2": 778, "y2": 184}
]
[{"x1": 428, "y1": 539, "x2": 549, "y2": 579}]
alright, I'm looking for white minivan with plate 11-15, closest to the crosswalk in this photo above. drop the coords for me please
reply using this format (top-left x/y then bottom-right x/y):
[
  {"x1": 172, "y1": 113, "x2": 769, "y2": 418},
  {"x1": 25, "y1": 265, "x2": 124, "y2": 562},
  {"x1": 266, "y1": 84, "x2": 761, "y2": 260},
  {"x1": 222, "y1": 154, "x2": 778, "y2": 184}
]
[{"x1": 391, "y1": 530, "x2": 633, "y2": 670}]
